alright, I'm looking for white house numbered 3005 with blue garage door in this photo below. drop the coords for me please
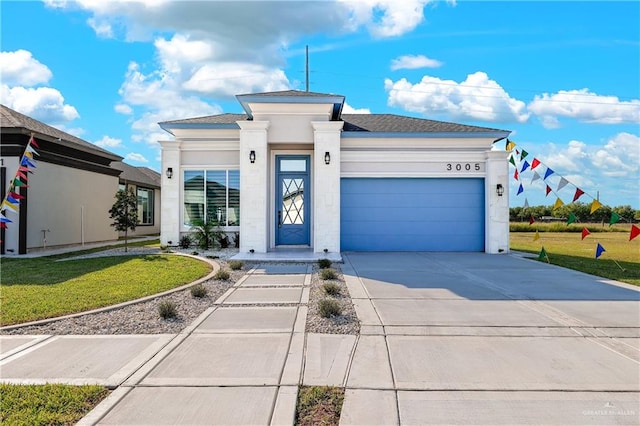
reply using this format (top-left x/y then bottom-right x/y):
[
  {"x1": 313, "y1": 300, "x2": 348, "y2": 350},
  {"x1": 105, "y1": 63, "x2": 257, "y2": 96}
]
[{"x1": 160, "y1": 90, "x2": 510, "y2": 253}]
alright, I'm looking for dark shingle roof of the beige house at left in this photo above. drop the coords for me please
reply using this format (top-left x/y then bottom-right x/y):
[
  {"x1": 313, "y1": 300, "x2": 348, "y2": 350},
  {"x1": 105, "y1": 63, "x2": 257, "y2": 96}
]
[{"x1": 0, "y1": 105, "x2": 122, "y2": 160}]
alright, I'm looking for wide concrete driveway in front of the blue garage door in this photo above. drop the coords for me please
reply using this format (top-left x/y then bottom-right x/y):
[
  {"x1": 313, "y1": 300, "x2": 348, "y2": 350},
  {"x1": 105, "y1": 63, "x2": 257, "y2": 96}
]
[{"x1": 341, "y1": 253, "x2": 640, "y2": 425}]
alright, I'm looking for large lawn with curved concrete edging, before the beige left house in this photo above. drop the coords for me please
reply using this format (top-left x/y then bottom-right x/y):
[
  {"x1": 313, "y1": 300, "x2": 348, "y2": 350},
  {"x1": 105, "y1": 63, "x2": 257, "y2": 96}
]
[{"x1": 0, "y1": 253, "x2": 211, "y2": 325}]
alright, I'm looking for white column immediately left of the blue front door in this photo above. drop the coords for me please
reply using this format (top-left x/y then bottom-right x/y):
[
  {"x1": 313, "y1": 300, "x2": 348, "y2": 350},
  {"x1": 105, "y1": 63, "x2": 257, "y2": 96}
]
[{"x1": 237, "y1": 121, "x2": 269, "y2": 253}]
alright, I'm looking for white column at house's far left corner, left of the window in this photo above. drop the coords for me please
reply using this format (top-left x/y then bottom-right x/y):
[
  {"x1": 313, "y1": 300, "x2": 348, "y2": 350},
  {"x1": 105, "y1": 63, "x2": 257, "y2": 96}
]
[{"x1": 159, "y1": 141, "x2": 182, "y2": 245}]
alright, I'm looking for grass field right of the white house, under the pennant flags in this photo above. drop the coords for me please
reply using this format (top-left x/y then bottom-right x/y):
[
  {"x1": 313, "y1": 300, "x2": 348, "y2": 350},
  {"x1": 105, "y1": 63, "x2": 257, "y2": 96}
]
[{"x1": 510, "y1": 231, "x2": 640, "y2": 286}]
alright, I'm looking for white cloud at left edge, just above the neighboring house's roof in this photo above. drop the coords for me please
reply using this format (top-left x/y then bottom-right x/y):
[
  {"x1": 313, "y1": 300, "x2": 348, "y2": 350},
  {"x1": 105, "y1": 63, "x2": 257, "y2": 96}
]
[{"x1": 0, "y1": 84, "x2": 80, "y2": 125}]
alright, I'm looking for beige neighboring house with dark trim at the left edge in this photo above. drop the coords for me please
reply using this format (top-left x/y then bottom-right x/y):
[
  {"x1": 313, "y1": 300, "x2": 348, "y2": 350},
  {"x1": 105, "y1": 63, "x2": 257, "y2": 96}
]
[{"x1": 0, "y1": 105, "x2": 160, "y2": 255}]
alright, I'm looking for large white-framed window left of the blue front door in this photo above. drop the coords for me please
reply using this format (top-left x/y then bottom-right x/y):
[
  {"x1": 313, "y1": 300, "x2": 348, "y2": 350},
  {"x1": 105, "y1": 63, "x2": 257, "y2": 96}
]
[{"x1": 184, "y1": 170, "x2": 240, "y2": 226}]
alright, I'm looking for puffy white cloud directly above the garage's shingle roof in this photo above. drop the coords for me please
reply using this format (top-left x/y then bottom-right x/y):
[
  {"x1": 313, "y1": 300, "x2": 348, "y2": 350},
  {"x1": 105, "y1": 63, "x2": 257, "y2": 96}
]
[{"x1": 385, "y1": 71, "x2": 529, "y2": 123}]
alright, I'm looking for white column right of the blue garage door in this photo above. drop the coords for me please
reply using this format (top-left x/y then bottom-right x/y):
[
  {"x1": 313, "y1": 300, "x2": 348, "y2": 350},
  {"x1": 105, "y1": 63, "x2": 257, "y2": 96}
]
[{"x1": 484, "y1": 151, "x2": 509, "y2": 254}]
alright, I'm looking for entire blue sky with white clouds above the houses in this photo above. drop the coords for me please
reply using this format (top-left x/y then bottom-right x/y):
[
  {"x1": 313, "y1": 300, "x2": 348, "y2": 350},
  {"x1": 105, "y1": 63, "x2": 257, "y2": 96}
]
[{"x1": 0, "y1": 0, "x2": 640, "y2": 208}]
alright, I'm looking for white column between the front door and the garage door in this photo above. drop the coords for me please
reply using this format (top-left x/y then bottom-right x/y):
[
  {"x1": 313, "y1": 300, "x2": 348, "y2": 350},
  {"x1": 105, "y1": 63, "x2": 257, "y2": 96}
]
[{"x1": 311, "y1": 121, "x2": 344, "y2": 253}]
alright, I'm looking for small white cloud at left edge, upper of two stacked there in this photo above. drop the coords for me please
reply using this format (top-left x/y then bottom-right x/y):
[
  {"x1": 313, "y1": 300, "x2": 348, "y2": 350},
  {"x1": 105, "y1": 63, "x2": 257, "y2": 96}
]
[{"x1": 0, "y1": 49, "x2": 52, "y2": 86}]
